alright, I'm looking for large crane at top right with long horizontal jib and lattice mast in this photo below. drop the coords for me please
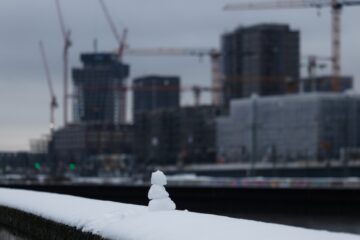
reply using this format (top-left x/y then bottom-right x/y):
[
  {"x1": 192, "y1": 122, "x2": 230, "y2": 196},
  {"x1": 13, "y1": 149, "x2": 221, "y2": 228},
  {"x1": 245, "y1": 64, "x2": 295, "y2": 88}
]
[{"x1": 224, "y1": 0, "x2": 360, "y2": 91}]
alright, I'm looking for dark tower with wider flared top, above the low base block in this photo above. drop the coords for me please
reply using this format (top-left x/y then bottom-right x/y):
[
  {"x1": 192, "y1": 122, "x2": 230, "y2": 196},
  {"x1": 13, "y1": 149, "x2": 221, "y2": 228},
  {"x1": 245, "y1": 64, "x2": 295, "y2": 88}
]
[{"x1": 72, "y1": 53, "x2": 129, "y2": 123}]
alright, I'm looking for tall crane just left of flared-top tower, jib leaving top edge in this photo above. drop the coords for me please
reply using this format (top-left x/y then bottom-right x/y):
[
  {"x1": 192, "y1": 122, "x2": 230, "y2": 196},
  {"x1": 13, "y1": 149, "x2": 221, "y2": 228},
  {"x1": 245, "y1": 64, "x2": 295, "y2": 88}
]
[{"x1": 55, "y1": 0, "x2": 72, "y2": 126}]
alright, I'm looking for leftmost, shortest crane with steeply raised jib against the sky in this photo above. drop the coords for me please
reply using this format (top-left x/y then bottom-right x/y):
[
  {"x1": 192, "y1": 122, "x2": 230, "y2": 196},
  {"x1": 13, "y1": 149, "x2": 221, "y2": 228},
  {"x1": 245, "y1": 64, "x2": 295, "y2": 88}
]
[{"x1": 39, "y1": 41, "x2": 58, "y2": 133}]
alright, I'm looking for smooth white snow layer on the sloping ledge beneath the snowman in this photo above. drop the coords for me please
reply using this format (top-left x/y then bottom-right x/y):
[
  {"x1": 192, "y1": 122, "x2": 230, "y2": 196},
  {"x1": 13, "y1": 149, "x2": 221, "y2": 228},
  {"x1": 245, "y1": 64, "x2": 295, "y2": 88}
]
[{"x1": 0, "y1": 188, "x2": 360, "y2": 240}]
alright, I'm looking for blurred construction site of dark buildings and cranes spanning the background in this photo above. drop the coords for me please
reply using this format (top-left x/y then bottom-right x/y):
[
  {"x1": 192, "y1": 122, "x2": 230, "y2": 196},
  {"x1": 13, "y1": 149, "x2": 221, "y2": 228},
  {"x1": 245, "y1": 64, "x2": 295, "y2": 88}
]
[{"x1": 0, "y1": 0, "x2": 360, "y2": 180}]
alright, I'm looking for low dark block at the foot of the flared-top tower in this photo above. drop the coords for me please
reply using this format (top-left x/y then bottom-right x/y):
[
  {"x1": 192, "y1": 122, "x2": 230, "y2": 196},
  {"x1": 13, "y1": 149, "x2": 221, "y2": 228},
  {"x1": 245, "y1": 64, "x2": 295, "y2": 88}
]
[{"x1": 50, "y1": 123, "x2": 133, "y2": 174}]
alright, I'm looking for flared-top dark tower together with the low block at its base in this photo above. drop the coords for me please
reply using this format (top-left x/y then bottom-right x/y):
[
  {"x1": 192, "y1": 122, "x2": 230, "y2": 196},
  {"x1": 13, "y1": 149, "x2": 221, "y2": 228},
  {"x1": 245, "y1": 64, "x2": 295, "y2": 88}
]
[{"x1": 49, "y1": 53, "x2": 133, "y2": 174}]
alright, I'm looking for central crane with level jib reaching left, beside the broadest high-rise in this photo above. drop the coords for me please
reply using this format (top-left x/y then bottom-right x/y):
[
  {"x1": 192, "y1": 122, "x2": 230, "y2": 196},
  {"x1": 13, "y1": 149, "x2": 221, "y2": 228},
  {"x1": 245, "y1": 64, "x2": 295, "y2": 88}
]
[{"x1": 124, "y1": 48, "x2": 222, "y2": 106}]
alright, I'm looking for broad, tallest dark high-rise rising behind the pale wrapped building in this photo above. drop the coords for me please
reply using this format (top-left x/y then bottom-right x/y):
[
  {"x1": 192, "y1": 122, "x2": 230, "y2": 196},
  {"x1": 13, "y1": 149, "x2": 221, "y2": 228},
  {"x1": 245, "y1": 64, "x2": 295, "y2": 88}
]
[{"x1": 221, "y1": 24, "x2": 300, "y2": 105}]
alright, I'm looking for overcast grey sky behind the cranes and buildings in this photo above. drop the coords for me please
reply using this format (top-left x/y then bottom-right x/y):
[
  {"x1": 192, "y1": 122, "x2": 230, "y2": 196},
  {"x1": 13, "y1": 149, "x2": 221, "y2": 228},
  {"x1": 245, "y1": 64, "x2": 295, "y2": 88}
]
[{"x1": 0, "y1": 0, "x2": 360, "y2": 151}]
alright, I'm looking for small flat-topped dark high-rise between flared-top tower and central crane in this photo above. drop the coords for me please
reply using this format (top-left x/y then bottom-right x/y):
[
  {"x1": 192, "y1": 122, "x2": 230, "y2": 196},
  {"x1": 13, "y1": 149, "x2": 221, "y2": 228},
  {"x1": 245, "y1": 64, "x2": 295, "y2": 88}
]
[{"x1": 133, "y1": 75, "x2": 180, "y2": 115}]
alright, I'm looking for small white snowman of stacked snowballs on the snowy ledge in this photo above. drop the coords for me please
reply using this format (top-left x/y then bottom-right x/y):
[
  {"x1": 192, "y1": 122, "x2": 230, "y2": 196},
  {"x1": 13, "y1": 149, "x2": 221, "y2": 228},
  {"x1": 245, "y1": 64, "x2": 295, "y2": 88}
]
[{"x1": 148, "y1": 170, "x2": 176, "y2": 212}]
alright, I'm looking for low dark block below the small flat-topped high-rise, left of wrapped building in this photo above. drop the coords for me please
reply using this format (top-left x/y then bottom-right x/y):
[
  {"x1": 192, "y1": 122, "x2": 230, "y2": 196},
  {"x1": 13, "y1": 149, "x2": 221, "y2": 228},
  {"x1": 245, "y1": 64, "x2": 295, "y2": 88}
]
[{"x1": 134, "y1": 106, "x2": 219, "y2": 166}]
